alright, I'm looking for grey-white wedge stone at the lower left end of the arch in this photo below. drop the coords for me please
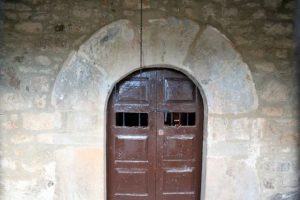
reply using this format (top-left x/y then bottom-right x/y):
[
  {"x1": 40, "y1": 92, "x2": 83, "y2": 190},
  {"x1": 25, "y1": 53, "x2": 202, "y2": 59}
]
[{"x1": 52, "y1": 54, "x2": 105, "y2": 111}]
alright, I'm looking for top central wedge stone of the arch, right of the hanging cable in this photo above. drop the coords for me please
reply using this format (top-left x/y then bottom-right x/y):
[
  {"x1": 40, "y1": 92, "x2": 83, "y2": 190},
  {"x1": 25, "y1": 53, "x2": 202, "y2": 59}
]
[{"x1": 143, "y1": 18, "x2": 199, "y2": 66}]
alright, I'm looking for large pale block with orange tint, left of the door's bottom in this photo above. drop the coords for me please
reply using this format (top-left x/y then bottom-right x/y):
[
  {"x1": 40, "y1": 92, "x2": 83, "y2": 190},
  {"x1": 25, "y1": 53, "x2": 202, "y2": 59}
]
[{"x1": 55, "y1": 147, "x2": 106, "y2": 200}]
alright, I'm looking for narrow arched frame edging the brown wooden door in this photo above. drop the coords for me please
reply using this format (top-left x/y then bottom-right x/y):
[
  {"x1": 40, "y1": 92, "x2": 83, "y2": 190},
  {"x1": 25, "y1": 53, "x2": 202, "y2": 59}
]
[{"x1": 104, "y1": 65, "x2": 208, "y2": 200}]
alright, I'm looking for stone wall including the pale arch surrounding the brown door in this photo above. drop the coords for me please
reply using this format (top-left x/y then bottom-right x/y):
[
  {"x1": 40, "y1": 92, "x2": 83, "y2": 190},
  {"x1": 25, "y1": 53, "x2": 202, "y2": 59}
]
[{"x1": 0, "y1": 0, "x2": 300, "y2": 200}]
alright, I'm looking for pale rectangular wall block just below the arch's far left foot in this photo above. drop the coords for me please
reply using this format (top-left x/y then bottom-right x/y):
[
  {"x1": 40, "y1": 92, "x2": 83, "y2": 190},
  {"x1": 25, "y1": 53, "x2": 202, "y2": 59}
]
[{"x1": 22, "y1": 112, "x2": 62, "y2": 131}]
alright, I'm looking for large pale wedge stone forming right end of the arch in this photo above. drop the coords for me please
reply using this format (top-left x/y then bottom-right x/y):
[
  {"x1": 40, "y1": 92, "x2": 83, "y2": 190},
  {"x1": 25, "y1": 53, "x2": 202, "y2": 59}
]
[{"x1": 185, "y1": 27, "x2": 258, "y2": 114}]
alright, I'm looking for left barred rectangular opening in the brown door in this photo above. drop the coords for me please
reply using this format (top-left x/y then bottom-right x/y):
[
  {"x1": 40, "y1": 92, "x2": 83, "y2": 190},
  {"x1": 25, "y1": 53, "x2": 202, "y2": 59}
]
[{"x1": 116, "y1": 112, "x2": 148, "y2": 127}]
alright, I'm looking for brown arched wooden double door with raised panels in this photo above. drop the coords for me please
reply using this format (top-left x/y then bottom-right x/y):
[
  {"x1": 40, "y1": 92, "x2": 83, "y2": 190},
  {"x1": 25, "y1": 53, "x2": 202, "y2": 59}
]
[{"x1": 107, "y1": 69, "x2": 203, "y2": 200}]
